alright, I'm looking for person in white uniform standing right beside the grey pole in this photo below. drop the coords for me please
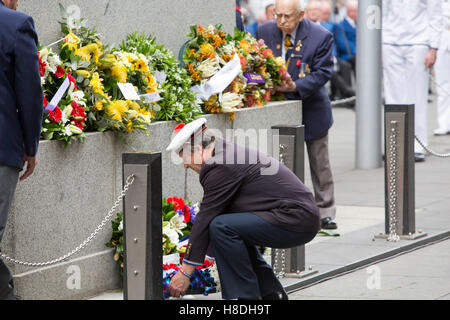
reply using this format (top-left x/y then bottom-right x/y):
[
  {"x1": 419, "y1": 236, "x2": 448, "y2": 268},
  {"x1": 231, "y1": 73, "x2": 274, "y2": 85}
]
[{"x1": 382, "y1": 0, "x2": 443, "y2": 162}]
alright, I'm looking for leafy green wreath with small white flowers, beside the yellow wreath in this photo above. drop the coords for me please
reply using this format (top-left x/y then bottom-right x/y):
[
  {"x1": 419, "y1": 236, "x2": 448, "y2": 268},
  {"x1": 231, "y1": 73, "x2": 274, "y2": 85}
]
[{"x1": 120, "y1": 33, "x2": 202, "y2": 123}]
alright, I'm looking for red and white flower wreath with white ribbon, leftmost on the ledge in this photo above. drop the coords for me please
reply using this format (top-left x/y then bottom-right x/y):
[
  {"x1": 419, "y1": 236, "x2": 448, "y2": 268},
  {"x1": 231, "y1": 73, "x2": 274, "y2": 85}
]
[{"x1": 38, "y1": 47, "x2": 88, "y2": 145}]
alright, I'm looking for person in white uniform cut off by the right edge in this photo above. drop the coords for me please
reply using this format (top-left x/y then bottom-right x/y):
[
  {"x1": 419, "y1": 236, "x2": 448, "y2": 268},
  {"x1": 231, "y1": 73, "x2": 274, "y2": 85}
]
[{"x1": 434, "y1": 0, "x2": 450, "y2": 136}]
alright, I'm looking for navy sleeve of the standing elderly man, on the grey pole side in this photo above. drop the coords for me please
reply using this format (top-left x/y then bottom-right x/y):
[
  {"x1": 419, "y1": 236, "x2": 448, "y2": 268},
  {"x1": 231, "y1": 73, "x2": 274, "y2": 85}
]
[{"x1": 295, "y1": 32, "x2": 333, "y2": 100}]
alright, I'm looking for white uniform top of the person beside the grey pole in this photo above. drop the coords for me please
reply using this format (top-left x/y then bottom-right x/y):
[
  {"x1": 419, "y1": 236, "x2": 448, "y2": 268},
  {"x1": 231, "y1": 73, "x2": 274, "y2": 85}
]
[{"x1": 382, "y1": 0, "x2": 443, "y2": 49}]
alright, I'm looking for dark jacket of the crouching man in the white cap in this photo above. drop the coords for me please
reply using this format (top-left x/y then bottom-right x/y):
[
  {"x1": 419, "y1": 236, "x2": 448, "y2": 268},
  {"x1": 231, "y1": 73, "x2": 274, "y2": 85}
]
[{"x1": 184, "y1": 140, "x2": 320, "y2": 265}]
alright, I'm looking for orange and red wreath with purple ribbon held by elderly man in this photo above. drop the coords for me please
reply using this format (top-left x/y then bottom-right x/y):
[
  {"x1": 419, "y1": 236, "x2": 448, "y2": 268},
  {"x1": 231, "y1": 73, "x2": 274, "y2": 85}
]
[{"x1": 233, "y1": 29, "x2": 287, "y2": 108}]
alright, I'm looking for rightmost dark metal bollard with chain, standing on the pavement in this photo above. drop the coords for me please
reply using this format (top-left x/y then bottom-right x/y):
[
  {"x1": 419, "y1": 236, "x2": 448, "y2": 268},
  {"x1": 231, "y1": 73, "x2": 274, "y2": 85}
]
[{"x1": 375, "y1": 105, "x2": 427, "y2": 241}]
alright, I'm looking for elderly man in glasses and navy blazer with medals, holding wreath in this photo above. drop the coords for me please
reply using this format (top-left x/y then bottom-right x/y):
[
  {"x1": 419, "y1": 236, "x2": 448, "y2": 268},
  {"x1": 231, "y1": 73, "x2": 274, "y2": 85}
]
[{"x1": 256, "y1": 0, "x2": 337, "y2": 229}]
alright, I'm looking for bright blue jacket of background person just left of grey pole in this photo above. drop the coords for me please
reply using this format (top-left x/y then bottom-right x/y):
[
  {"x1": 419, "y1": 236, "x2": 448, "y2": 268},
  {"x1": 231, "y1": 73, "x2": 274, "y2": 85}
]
[{"x1": 335, "y1": 19, "x2": 356, "y2": 61}]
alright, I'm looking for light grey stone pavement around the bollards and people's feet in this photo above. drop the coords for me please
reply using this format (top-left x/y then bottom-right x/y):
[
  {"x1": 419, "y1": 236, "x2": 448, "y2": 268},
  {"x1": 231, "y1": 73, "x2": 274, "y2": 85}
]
[{"x1": 89, "y1": 96, "x2": 450, "y2": 299}]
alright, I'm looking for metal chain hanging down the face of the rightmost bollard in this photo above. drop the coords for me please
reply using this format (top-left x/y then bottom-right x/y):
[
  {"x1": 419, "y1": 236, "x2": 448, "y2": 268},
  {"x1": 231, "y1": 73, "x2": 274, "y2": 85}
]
[{"x1": 387, "y1": 121, "x2": 400, "y2": 242}]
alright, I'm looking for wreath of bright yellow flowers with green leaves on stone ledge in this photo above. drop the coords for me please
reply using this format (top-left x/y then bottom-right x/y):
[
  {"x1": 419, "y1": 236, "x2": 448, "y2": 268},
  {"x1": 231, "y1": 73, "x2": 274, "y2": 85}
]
[{"x1": 60, "y1": 5, "x2": 152, "y2": 132}]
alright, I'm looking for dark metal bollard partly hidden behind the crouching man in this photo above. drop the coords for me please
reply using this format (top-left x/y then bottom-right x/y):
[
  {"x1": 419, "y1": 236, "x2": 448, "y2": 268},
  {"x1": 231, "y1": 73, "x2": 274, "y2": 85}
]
[{"x1": 272, "y1": 125, "x2": 317, "y2": 278}]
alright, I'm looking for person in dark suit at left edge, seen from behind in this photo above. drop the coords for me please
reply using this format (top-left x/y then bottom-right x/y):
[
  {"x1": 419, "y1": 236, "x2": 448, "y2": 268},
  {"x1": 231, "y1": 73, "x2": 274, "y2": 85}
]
[{"x1": 0, "y1": 0, "x2": 43, "y2": 300}]
